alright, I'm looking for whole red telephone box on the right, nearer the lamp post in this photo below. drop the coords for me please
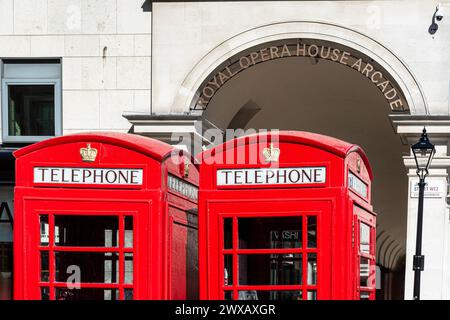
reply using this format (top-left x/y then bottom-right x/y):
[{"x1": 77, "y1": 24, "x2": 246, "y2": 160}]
[{"x1": 199, "y1": 131, "x2": 376, "y2": 300}]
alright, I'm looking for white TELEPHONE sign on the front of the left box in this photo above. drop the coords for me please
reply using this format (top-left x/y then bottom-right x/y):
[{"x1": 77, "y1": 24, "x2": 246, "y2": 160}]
[{"x1": 33, "y1": 167, "x2": 143, "y2": 186}]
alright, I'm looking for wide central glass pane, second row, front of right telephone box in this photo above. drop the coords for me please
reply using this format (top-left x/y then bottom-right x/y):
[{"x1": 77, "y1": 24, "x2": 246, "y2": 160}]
[{"x1": 238, "y1": 254, "x2": 302, "y2": 285}]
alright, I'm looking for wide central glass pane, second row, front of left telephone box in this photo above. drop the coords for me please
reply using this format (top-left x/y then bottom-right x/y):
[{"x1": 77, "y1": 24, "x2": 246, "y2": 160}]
[{"x1": 55, "y1": 252, "x2": 119, "y2": 283}]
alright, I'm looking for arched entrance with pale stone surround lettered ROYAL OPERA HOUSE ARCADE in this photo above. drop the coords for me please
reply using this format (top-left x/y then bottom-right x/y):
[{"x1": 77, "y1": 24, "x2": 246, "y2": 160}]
[{"x1": 185, "y1": 22, "x2": 428, "y2": 299}]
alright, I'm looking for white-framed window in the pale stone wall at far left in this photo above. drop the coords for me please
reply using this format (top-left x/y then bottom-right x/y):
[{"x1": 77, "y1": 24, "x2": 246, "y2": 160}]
[{"x1": 1, "y1": 59, "x2": 62, "y2": 143}]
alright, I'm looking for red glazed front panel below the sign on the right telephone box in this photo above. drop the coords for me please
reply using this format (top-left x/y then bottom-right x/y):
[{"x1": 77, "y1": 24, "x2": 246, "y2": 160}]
[{"x1": 208, "y1": 199, "x2": 331, "y2": 300}]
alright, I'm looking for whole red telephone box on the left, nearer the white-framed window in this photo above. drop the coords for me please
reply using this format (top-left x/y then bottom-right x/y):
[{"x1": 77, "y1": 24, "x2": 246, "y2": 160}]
[{"x1": 14, "y1": 133, "x2": 198, "y2": 300}]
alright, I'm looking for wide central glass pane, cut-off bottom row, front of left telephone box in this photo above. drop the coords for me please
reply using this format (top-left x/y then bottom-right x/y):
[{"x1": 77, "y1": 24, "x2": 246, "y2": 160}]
[{"x1": 55, "y1": 288, "x2": 119, "y2": 300}]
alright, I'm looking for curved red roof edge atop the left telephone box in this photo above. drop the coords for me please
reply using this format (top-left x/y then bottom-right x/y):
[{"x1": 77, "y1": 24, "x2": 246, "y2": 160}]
[{"x1": 14, "y1": 132, "x2": 181, "y2": 161}]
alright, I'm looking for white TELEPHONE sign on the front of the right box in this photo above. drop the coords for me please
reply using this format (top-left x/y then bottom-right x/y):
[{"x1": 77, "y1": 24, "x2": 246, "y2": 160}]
[{"x1": 217, "y1": 167, "x2": 326, "y2": 186}]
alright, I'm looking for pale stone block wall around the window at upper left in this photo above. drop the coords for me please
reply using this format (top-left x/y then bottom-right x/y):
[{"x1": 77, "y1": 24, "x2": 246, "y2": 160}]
[{"x1": 0, "y1": 0, "x2": 152, "y2": 141}]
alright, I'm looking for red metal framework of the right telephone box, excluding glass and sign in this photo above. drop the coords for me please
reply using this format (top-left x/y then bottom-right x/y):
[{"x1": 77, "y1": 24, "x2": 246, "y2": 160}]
[{"x1": 198, "y1": 131, "x2": 376, "y2": 299}]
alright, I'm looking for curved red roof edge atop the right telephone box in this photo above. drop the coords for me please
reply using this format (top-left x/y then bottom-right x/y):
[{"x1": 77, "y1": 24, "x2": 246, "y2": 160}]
[{"x1": 197, "y1": 131, "x2": 373, "y2": 179}]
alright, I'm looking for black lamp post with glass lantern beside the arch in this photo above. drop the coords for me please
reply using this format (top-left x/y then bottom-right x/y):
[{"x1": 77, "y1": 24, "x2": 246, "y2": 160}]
[{"x1": 411, "y1": 128, "x2": 436, "y2": 300}]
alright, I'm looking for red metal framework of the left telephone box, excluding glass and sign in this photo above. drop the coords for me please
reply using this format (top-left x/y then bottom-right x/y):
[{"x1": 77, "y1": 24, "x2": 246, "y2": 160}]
[{"x1": 14, "y1": 133, "x2": 198, "y2": 299}]
